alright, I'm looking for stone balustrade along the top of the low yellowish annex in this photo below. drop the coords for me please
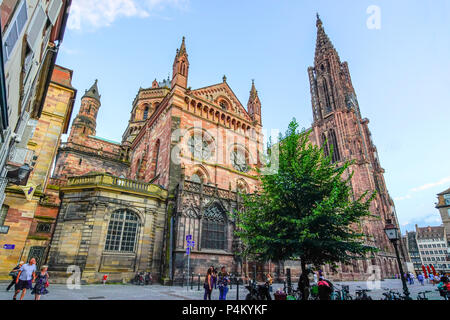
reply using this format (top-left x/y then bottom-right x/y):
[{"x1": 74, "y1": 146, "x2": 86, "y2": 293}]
[{"x1": 67, "y1": 174, "x2": 168, "y2": 198}]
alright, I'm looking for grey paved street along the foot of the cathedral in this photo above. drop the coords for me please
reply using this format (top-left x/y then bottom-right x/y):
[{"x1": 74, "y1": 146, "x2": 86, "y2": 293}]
[{"x1": 0, "y1": 280, "x2": 443, "y2": 300}]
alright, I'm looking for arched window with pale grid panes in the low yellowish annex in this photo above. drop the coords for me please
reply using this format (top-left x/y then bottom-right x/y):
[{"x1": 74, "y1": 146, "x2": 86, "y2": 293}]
[{"x1": 105, "y1": 209, "x2": 139, "y2": 253}]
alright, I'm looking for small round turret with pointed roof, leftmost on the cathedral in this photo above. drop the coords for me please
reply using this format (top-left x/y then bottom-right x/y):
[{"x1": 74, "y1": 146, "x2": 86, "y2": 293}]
[{"x1": 68, "y1": 80, "x2": 101, "y2": 141}]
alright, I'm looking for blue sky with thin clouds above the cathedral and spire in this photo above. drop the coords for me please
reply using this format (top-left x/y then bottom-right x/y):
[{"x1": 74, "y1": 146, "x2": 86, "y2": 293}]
[{"x1": 57, "y1": 0, "x2": 450, "y2": 231}]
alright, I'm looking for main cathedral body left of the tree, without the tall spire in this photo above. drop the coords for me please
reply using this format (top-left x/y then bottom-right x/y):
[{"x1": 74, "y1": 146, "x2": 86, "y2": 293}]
[{"x1": 49, "y1": 38, "x2": 262, "y2": 283}]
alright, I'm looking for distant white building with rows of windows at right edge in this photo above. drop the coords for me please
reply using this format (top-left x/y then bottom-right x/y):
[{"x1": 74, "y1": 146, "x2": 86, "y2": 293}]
[{"x1": 416, "y1": 225, "x2": 450, "y2": 272}]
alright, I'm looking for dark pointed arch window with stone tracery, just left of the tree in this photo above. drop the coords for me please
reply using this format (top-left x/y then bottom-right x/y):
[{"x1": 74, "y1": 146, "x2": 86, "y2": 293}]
[{"x1": 202, "y1": 202, "x2": 227, "y2": 250}]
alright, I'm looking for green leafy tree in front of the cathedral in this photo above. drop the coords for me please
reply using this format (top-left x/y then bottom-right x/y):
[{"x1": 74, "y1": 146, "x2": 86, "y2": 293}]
[{"x1": 236, "y1": 119, "x2": 376, "y2": 280}]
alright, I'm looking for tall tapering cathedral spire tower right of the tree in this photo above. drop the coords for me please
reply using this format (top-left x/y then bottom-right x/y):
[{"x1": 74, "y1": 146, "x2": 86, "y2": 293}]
[{"x1": 308, "y1": 15, "x2": 398, "y2": 277}]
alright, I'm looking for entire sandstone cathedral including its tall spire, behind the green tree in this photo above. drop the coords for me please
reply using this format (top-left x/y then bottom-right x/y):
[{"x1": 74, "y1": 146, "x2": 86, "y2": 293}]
[{"x1": 29, "y1": 19, "x2": 398, "y2": 283}]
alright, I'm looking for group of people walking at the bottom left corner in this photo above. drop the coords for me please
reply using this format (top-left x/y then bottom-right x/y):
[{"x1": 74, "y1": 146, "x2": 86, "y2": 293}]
[{"x1": 6, "y1": 258, "x2": 49, "y2": 300}]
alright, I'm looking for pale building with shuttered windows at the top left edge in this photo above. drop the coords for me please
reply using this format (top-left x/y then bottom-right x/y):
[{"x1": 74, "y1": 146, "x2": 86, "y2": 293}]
[{"x1": 0, "y1": 0, "x2": 71, "y2": 205}]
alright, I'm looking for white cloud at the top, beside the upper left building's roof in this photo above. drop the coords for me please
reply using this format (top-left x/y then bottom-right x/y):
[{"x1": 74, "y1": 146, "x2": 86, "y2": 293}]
[{"x1": 67, "y1": 0, "x2": 189, "y2": 30}]
